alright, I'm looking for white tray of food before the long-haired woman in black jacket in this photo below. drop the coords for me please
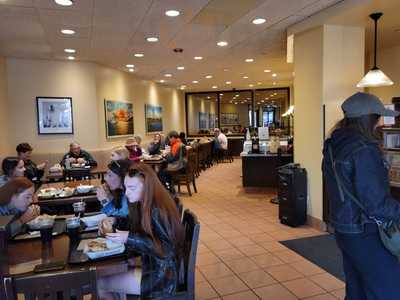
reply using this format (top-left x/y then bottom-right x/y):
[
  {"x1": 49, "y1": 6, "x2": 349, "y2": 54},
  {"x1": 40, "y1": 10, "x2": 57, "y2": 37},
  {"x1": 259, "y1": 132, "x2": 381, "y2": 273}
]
[{"x1": 78, "y1": 238, "x2": 125, "y2": 259}]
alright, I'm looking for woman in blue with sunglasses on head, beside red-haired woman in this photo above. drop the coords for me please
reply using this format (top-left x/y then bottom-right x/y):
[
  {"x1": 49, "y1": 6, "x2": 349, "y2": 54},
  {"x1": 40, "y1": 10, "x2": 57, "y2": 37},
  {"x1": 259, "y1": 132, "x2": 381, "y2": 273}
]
[{"x1": 97, "y1": 160, "x2": 131, "y2": 217}]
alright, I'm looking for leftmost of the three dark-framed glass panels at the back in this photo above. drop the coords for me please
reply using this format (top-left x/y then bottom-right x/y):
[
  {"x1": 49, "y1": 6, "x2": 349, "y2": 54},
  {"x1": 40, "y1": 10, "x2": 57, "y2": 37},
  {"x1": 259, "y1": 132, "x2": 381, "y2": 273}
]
[{"x1": 186, "y1": 93, "x2": 218, "y2": 136}]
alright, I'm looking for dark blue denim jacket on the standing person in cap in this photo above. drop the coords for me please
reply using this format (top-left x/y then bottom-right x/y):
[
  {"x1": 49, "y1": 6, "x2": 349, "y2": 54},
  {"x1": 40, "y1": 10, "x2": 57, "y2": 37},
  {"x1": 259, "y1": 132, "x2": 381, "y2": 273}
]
[{"x1": 322, "y1": 129, "x2": 400, "y2": 233}]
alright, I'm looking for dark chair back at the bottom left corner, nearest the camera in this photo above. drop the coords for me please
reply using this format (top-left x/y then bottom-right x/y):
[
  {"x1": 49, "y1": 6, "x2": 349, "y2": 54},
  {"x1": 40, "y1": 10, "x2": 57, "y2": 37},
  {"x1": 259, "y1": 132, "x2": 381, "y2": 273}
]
[{"x1": 4, "y1": 268, "x2": 98, "y2": 300}]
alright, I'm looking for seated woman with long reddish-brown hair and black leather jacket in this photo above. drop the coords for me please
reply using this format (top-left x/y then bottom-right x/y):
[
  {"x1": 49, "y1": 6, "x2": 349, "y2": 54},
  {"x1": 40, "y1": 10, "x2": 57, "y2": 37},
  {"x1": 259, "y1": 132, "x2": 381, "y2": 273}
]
[{"x1": 98, "y1": 163, "x2": 184, "y2": 299}]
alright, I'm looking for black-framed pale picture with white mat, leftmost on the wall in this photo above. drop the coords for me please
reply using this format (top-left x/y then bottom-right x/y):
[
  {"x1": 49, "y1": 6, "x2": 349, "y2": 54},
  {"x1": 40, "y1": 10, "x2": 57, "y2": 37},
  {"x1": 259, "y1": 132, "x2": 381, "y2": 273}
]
[{"x1": 36, "y1": 97, "x2": 74, "y2": 134}]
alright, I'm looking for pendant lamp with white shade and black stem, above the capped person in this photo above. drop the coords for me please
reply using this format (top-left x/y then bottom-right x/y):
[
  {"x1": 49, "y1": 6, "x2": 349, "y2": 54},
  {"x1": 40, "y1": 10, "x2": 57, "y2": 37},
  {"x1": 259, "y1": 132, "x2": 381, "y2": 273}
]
[{"x1": 357, "y1": 13, "x2": 393, "y2": 88}]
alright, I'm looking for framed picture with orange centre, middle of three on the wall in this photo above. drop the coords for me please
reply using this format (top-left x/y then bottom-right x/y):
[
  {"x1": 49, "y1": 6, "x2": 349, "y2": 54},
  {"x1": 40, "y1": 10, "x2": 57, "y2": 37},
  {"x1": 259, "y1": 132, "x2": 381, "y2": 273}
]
[{"x1": 104, "y1": 100, "x2": 133, "y2": 139}]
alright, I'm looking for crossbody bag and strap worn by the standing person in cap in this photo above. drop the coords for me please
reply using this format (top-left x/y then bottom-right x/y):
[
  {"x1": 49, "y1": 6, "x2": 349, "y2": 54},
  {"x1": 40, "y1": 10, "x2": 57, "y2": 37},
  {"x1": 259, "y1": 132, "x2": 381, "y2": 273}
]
[{"x1": 328, "y1": 146, "x2": 400, "y2": 261}]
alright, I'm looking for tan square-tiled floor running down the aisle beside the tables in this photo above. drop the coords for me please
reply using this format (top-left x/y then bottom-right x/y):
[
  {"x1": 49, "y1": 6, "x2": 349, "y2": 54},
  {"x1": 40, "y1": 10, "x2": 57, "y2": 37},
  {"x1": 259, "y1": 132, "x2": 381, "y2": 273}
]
[{"x1": 181, "y1": 159, "x2": 344, "y2": 300}]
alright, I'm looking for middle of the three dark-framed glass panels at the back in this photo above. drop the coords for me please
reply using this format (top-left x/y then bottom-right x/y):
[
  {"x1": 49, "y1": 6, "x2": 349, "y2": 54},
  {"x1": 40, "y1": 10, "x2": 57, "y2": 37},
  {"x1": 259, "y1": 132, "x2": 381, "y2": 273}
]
[{"x1": 219, "y1": 91, "x2": 252, "y2": 134}]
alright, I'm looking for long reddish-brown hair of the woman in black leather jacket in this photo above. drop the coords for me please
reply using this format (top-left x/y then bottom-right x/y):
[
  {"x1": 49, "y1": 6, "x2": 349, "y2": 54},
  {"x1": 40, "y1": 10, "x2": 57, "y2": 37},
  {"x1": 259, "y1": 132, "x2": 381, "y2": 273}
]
[{"x1": 127, "y1": 162, "x2": 183, "y2": 256}]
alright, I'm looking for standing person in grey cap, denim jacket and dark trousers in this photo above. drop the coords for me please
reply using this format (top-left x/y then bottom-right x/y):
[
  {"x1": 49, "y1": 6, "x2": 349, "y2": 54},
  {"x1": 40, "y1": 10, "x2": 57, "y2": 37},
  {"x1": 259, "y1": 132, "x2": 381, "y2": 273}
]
[{"x1": 322, "y1": 93, "x2": 400, "y2": 300}]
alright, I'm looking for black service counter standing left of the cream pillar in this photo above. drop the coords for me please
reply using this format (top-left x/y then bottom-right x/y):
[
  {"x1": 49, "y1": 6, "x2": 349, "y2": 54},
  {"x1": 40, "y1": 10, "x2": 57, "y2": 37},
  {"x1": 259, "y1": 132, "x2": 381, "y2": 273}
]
[{"x1": 240, "y1": 153, "x2": 293, "y2": 188}]
